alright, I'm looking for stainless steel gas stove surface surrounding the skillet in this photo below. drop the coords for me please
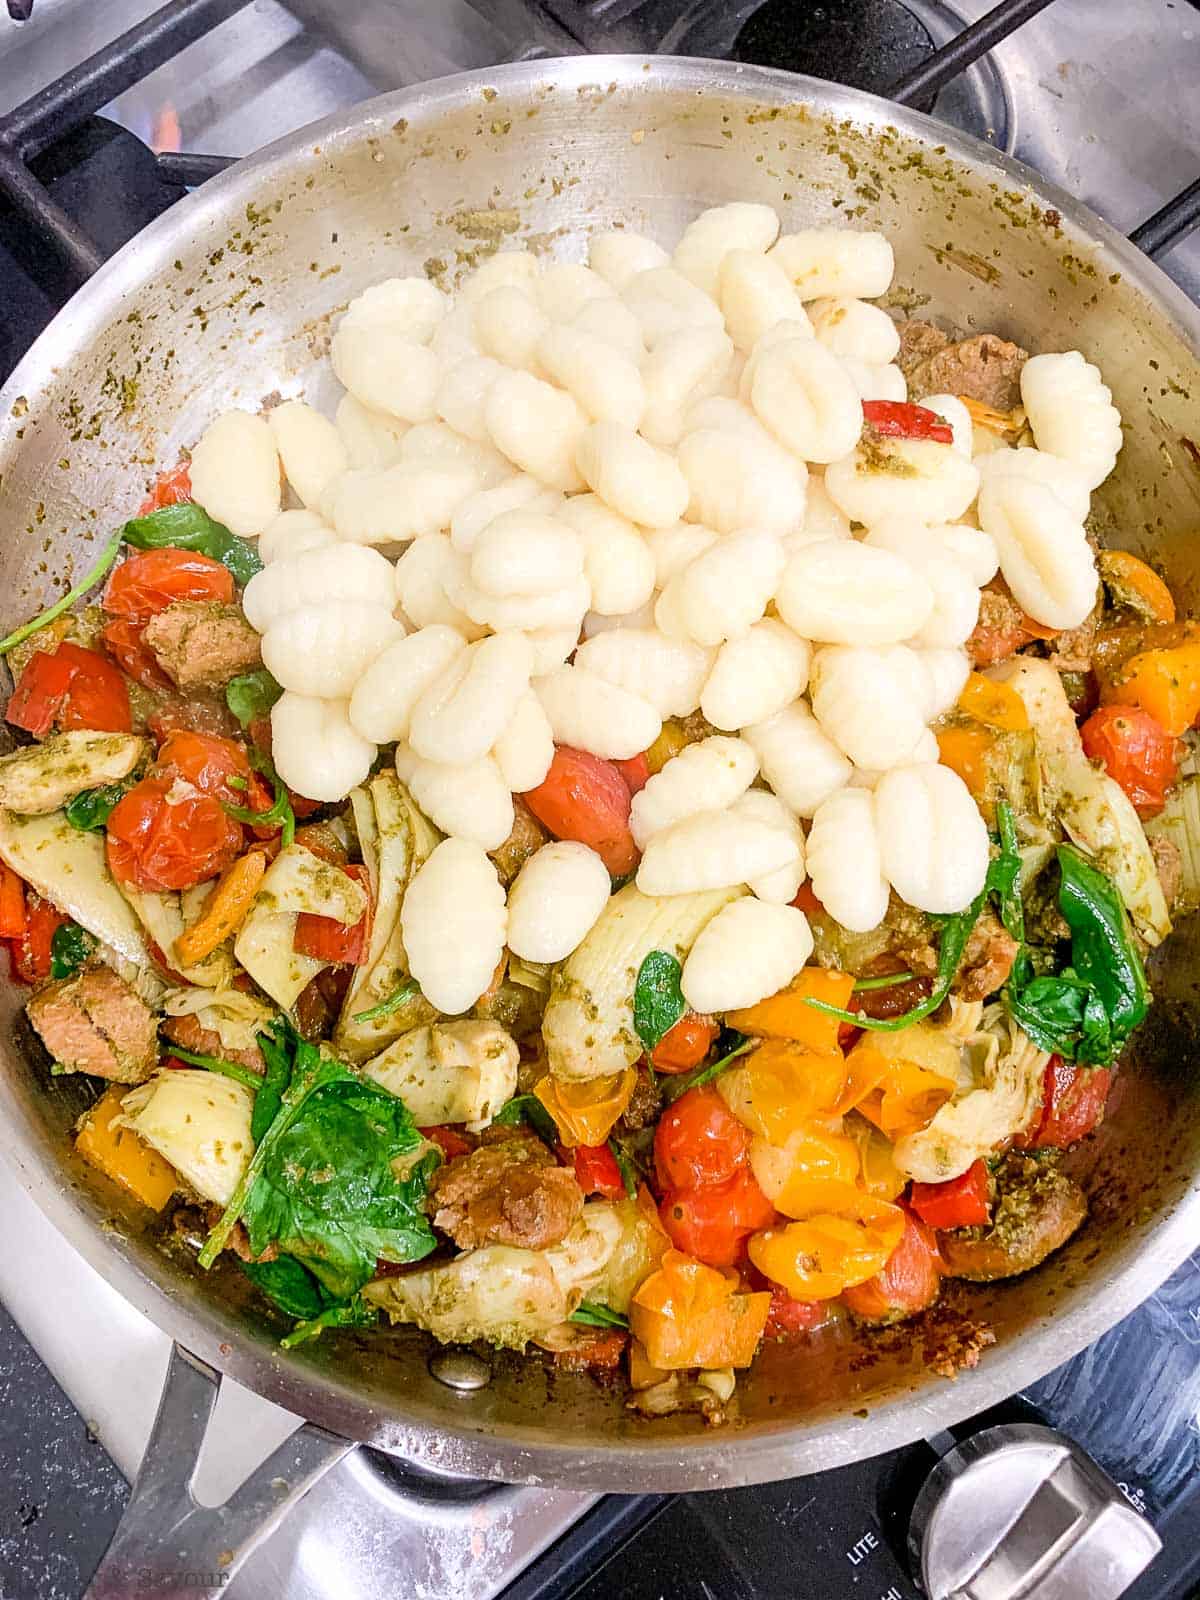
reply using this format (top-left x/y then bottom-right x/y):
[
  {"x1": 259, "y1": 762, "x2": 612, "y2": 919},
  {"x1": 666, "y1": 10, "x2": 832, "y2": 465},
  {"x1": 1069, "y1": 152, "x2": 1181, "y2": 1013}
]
[{"x1": 0, "y1": 0, "x2": 1200, "y2": 1600}]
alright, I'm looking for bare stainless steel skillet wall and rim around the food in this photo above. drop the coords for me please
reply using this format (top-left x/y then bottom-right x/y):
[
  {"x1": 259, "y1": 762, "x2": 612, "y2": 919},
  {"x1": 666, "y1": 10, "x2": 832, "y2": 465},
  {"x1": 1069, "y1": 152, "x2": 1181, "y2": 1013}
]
[{"x1": 0, "y1": 58, "x2": 1200, "y2": 1491}]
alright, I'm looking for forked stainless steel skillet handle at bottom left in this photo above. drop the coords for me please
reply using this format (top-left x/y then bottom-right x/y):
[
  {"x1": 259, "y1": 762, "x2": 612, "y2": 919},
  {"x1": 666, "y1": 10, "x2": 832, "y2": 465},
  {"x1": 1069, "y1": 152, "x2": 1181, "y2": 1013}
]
[{"x1": 82, "y1": 1344, "x2": 355, "y2": 1600}]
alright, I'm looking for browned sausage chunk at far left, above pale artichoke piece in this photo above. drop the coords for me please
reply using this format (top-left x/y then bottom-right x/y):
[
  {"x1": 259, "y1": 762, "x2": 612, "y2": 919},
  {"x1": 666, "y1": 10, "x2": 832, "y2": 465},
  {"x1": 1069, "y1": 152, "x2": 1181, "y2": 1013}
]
[{"x1": 26, "y1": 966, "x2": 158, "y2": 1083}]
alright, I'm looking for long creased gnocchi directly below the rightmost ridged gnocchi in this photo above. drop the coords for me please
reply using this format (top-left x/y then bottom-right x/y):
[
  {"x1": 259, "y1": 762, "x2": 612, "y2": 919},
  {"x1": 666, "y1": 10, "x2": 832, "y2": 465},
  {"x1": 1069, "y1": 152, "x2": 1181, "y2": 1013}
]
[{"x1": 979, "y1": 477, "x2": 1099, "y2": 629}]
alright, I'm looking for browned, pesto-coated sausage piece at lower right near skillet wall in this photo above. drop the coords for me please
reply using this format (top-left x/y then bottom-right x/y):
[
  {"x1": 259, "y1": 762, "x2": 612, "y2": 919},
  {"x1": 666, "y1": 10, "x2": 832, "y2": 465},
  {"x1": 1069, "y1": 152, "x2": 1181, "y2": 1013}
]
[{"x1": 938, "y1": 1155, "x2": 1088, "y2": 1283}]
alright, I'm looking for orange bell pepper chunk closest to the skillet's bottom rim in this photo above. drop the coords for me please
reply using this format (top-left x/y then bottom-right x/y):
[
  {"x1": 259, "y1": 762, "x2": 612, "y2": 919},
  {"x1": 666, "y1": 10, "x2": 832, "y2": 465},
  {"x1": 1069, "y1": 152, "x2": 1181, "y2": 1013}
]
[{"x1": 629, "y1": 1250, "x2": 771, "y2": 1371}]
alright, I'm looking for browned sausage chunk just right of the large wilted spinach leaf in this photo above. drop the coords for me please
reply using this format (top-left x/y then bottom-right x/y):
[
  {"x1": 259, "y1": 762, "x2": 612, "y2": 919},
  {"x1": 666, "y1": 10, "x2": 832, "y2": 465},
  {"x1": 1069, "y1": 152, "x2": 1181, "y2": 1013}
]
[{"x1": 430, "y1": 1130, "x2": 584, "y2": 1250}]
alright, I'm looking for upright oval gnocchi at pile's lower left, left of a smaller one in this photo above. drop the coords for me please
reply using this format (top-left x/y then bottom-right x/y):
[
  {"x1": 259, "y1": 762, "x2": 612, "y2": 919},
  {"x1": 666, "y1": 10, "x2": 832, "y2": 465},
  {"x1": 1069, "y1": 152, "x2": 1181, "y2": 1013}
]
[{"x1": 400, "y1": 838, "x2": 509, "y2": 1016}]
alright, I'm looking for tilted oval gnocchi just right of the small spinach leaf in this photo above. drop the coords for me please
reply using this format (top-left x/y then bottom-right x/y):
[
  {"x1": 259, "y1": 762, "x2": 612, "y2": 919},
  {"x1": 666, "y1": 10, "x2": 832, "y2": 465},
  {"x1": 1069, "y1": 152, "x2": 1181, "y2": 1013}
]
[{"x1": 680, "y1": 896, "x2": 813, "y2": 1013}]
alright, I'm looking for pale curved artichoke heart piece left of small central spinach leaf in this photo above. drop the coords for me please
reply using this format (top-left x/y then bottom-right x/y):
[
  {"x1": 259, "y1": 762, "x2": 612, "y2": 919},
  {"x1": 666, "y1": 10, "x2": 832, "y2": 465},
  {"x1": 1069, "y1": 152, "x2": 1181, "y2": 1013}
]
[{"x1": 542, "y1": 883, "x2": 746, "y2": 1080}]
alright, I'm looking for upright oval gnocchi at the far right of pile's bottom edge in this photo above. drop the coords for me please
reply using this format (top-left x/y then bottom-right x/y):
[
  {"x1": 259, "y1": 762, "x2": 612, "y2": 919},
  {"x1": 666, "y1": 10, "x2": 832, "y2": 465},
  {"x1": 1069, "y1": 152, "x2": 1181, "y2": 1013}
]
[{"x1": 875, "y1": 762, "x2": 989, "y2": 914}]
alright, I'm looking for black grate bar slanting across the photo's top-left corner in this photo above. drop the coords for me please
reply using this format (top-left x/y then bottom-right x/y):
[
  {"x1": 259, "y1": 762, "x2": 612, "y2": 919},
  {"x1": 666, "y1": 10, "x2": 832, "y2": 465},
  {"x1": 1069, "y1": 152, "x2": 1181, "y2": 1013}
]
[{"x1": 0, "y1": 0, "x2": 251, "y2": 162}]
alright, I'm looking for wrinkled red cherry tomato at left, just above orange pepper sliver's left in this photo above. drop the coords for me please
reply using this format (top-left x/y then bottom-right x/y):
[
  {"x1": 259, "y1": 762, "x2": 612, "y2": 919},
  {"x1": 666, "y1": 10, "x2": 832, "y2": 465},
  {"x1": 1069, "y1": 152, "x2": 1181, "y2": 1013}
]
[{"x1": 107, "y1": 773, "x2": 243, "y2": 890}]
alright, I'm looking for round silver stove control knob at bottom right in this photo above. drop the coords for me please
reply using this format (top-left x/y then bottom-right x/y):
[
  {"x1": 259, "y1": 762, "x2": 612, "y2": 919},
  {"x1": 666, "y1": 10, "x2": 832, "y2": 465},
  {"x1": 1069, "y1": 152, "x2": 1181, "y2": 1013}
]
[{"x1": 909, "y1": 1422, "x2": 1162, "y2": 1600}]
